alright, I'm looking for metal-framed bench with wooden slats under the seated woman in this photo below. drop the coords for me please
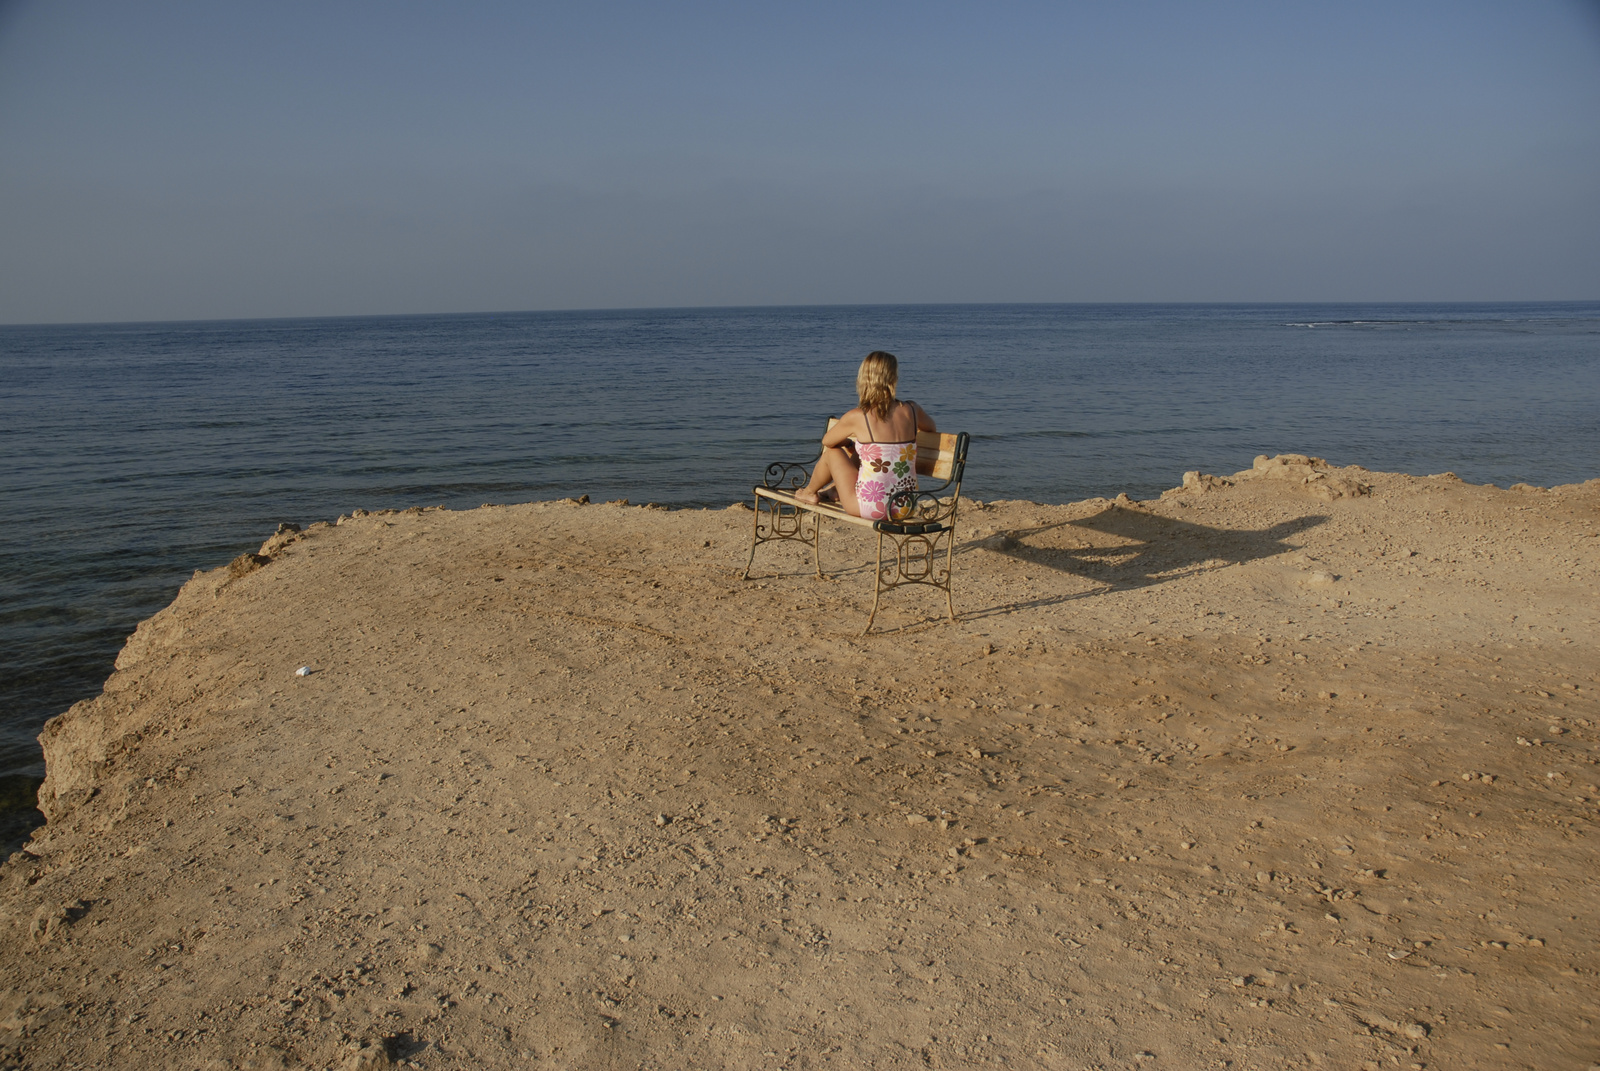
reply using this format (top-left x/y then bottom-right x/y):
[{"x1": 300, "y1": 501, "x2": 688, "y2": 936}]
[{"x1": 744, "y1": 419, "x2": 970, "y2": 634}]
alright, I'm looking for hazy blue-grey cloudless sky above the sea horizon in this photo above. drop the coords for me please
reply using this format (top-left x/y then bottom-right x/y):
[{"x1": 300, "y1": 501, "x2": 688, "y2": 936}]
[{"x1": 0, "y1": 0, "x2": 1600, "y2": 323}]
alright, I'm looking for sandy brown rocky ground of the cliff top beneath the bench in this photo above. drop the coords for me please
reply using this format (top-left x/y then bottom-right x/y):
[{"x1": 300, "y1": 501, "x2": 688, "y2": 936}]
[{"x1": 0, "y1": 458, "x2": 1600, "y2": 1071}]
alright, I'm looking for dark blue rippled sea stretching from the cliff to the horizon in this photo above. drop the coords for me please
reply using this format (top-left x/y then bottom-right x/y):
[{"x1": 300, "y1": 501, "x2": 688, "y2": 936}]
[{"x1": 0, "y1": 303, "x2": 1600, "y2": 839}]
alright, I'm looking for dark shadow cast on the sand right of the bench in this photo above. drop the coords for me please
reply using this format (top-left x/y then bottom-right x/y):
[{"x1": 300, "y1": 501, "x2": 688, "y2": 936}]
[{"x1": 955, "y1": 504, "x2": 1328, "y2": 618}]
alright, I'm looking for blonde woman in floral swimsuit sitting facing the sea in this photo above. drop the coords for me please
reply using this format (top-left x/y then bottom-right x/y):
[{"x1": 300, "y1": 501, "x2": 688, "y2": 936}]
[{"x1": 795, "y1": 351, "x2": 938, "y2": 520}]
